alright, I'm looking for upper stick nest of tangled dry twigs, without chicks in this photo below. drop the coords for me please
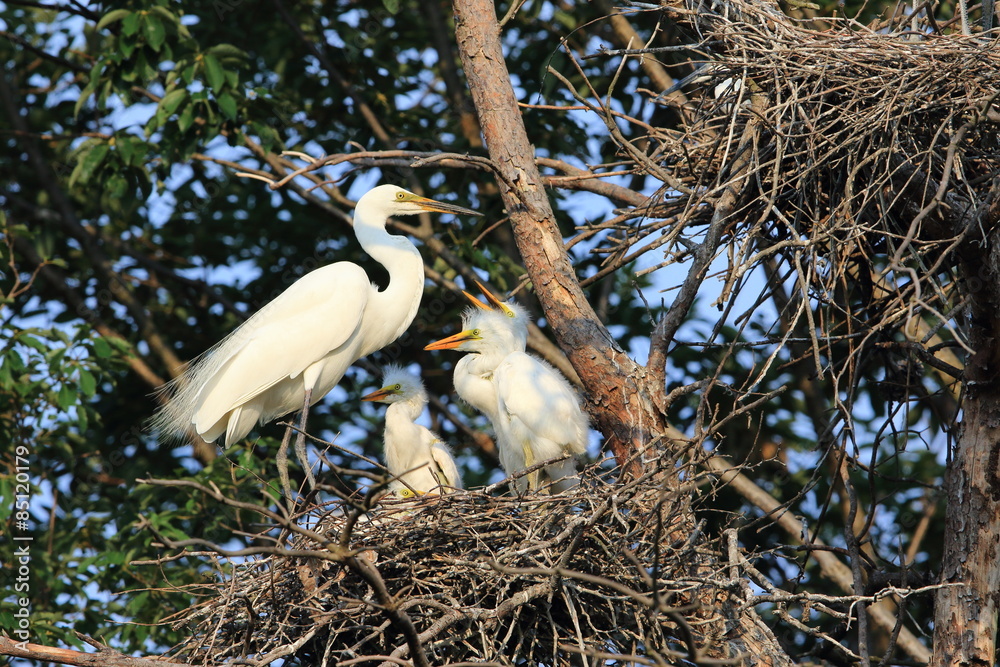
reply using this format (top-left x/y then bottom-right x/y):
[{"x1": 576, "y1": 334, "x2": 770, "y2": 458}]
[{"x1": 633, "y1": 0, "x2": 1000, "y2": 302}]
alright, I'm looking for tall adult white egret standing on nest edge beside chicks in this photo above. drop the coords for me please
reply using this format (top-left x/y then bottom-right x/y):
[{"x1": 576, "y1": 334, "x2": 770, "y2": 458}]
[{"x1": 152, "y1": 185, "x2": 479, "y2": 496}]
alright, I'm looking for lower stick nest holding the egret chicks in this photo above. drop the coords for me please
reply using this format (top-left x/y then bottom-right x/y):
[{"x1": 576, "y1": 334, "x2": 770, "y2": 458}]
[{"x1": 168, "y1": 468, "x2": 736, "y2": 664}]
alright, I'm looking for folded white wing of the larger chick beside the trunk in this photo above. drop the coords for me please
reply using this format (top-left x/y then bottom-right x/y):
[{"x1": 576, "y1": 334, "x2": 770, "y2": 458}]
[{"x1": 494, "y1": 352, "x2": 587, "y2": 454}]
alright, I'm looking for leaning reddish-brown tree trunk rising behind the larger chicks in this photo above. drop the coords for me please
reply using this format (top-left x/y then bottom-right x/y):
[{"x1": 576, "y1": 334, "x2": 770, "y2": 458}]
[{"x1": 454, "y1": 0, "x2": 666, "y2": 474}]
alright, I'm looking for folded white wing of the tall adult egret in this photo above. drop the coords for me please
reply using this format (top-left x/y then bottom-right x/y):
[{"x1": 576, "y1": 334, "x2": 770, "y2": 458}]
[{"x1": 192, "y1": 262, "x2": 371, "y2": 427}]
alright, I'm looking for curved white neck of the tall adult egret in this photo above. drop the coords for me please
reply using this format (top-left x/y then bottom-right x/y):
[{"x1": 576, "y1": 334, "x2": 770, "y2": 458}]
[{"x1": 354, "y1": 206, "x2": 424, "y2": 354}]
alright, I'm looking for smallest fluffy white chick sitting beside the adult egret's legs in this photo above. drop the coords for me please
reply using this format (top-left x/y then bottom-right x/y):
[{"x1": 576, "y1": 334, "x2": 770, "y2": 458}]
[{"x1": 361, "y1": 366, "x2": 462, "y2": 498}]
